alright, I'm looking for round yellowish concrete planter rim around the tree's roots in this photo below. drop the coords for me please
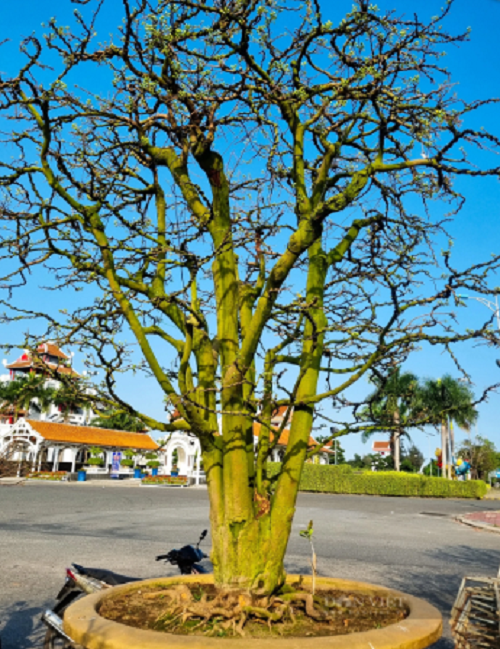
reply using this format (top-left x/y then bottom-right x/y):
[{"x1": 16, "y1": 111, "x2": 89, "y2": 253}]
[{"x1": 64, "y1": 575, "x2": 442, "y2": 649}]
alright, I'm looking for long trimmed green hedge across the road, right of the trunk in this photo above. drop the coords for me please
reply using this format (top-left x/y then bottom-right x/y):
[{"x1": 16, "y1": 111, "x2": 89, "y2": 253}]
[{"x1": 268, "y1": 462, "x2": 487, "y2": 498}]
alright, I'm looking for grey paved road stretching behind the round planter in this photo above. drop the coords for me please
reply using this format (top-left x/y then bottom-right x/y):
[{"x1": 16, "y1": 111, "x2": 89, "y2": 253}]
[{"x1": 0, "y1": 483, "x2": 500, "y2": 649}]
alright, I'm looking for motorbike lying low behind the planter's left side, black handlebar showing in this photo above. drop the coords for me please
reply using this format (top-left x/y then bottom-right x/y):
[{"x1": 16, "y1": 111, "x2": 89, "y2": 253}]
[{"x1": 42, "y1": 530, "x2": 208, "y2": 649}]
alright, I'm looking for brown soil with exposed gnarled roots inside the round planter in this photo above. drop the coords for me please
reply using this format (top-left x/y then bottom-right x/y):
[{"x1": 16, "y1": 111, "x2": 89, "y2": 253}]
[{"x1": 99, "y1": 583, "x2": 408, "y2": 638}]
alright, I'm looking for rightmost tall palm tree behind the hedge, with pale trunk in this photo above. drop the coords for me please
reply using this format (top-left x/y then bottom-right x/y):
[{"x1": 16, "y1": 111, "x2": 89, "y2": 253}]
[{"x1": 420, "y1": 374, "x2": 478, "y2": 478}]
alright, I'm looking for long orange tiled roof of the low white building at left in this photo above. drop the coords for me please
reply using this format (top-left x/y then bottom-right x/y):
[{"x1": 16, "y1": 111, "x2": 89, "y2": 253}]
[{"x1": 26, "y1": 419, "x2": 159, "y2": 451}]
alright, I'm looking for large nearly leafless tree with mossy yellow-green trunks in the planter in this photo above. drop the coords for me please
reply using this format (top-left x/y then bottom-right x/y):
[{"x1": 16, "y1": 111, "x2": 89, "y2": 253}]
[{"x1": 0, "y1": 0, "x2": 499, "y2": 592}]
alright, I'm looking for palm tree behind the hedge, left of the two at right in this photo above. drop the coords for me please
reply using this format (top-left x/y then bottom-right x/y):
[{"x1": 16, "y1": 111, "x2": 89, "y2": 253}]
[{"x1": 363, "y1": 367, "x2": 419, "y2": 471}]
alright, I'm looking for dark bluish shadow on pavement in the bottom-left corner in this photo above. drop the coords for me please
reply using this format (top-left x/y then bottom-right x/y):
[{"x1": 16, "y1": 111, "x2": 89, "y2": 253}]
[{"x1": 0, "y1": 600, "x2": 45, "y2": 649}]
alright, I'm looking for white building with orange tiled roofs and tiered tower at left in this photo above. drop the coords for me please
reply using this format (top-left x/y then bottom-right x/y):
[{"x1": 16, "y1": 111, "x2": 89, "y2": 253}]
[{"x1": 0, "y1": 342, "x2": 203, "y2": 484}]
